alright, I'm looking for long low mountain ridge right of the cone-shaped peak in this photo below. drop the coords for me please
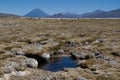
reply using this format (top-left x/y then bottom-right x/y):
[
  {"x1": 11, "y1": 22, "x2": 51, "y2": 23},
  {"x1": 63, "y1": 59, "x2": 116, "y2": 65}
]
[{"x1": 51, "y1": 9, "x2": 120, "y2": 18}]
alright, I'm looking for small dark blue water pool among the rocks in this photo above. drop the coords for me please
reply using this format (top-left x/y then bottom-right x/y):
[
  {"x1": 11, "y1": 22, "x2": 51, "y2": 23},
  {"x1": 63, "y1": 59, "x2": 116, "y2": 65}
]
[{"x1": 39, "y1": 57, "x2": 76, "y2": 72}]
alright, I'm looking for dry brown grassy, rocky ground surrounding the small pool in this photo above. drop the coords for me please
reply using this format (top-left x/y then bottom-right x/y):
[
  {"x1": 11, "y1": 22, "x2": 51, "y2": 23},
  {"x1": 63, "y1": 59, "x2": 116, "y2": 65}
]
[{"x1": 0, "y1": 18, "x2": 120, "y2": 80}]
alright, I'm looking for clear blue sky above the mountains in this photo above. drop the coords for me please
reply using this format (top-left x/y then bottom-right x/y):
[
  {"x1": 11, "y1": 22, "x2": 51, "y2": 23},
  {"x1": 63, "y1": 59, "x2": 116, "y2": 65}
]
[{"x1": 0, "y1": 0, "x2": 120, "y2": 15}]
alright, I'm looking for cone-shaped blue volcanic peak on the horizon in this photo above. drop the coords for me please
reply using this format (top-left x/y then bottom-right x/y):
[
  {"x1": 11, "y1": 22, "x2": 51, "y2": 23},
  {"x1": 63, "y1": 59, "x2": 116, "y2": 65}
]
[{"x1": 24, "y1": 8, "x2": 49, "y2": 17}]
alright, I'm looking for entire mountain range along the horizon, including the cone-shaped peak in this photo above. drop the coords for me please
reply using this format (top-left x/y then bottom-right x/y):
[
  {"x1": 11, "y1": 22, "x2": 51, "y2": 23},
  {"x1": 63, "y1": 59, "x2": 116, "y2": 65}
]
[{"x1": 0, "y1": 8, "x2": 120, "y2": 18}]
